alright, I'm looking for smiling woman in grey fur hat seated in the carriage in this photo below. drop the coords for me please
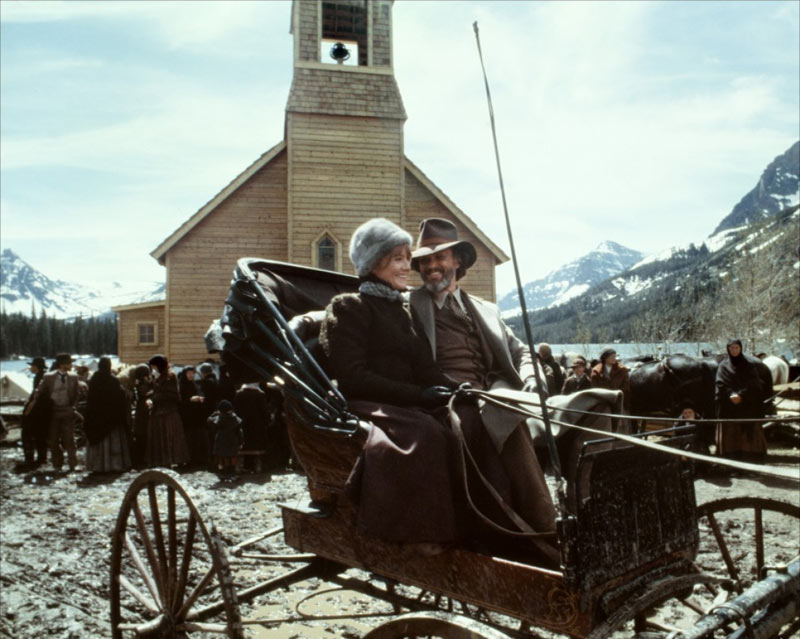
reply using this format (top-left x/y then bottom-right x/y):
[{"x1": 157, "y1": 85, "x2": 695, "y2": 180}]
[{"x1": 320, "y1": 218, "x2": 457, "y2": 553}]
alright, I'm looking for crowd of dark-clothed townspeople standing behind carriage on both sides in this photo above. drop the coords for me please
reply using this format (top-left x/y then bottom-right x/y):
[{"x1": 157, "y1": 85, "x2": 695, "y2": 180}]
[{"x1": 15, "y1": 340, "x2": 766, "y2": 476}]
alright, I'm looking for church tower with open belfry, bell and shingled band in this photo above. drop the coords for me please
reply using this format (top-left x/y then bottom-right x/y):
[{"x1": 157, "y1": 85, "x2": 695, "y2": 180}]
[{"x1": 286, "y1": 0, "x2": 406, "y2": 264}]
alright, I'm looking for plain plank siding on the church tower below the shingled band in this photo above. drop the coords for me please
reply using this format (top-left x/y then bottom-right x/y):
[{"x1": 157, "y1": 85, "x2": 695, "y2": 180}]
[{"x1": 286, "y1": 113, "x2": 403, "y2": 273}]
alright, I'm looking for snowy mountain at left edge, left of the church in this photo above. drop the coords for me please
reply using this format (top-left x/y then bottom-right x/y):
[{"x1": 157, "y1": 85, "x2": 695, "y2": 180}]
[{"x1": 0, "y1": 248, "x2": 165, "y2": 318}]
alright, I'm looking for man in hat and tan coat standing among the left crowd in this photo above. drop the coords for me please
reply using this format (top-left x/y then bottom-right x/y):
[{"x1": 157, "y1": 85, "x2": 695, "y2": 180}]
[{"x1": 27, "y1": 353, "x2": 87, "y2": 470}]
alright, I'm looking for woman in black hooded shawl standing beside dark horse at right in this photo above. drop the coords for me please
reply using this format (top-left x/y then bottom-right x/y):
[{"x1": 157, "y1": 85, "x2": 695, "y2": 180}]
[{"x1": 716, "y1": 339, "x2": 769, "y2": 458}]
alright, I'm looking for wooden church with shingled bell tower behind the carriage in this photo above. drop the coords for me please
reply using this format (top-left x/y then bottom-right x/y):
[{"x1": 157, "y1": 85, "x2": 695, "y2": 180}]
[{"x1": 114, "y1": 0, "x2": 508, "y2": 364}]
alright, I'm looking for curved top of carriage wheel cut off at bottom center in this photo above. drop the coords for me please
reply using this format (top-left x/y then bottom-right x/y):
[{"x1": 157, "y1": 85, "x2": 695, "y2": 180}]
[{"x1": 364, "y1": 611, "x2": 509, "y2": 639}]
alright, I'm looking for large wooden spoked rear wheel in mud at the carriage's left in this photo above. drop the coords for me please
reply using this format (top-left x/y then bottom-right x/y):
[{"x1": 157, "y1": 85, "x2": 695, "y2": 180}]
[{"x1": 111, "y1": 471, "x2": 244, "y2": 639}]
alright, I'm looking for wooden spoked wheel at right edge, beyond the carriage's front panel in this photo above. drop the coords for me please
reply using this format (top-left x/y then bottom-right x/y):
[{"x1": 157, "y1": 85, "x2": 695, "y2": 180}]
[{"x1": 697, "y1": 497, "x2": 800, "y2": 593}]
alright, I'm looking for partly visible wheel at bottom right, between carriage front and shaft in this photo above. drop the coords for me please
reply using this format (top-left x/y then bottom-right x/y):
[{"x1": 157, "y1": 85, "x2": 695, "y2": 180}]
[{"x1": 586, "y1": 574, "x2": 718, "y2": 639}]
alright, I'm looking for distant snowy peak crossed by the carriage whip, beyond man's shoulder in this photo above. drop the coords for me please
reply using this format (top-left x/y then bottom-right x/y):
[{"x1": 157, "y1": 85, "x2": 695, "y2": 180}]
[{"x1": 497, "y1": 240, "x2": 644, "y2": 317}]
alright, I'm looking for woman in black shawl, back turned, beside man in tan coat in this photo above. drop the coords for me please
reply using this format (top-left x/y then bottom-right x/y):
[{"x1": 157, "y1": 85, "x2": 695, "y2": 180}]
[{"x1": 84, "y1": 357, "x2": 131, "y2": 473}]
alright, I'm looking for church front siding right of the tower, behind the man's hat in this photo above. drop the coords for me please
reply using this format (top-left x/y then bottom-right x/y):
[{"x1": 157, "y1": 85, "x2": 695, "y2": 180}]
[{"x1": 405, "y1": 171, "x2": 497, "y2": 302}]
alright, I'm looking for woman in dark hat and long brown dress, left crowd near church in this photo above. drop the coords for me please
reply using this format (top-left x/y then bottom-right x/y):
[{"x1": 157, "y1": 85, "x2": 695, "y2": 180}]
[{"x1": 145, "y1": 355, "x2": 189, "y2": 468}]
